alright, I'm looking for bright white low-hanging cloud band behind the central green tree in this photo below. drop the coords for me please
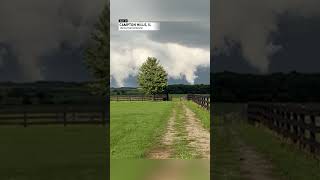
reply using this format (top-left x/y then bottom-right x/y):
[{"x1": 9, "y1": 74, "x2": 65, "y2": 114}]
[{"x1": 110, "y1": 36, "x2": 210, "y2": 87}]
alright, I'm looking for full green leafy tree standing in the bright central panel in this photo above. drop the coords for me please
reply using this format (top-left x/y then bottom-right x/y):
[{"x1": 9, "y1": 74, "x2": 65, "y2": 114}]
[{"x1": 138, "y1": 57, "x2": 168, "y2": 98}]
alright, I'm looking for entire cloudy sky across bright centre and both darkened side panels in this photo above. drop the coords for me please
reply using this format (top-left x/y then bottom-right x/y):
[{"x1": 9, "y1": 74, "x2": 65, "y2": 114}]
[{"x1": 0, "y1": 0, "x2": 320, "y2": 82}]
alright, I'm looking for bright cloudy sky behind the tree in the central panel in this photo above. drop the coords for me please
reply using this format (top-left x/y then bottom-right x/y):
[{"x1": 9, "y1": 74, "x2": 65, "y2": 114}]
[{"x1": 110, "y1": 0, "x2": 210, "y2": 87}]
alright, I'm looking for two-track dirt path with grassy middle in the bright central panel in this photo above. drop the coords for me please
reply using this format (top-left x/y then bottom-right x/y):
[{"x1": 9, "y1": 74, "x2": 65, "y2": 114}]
[{"x1": 147, "y1": 101, "x2": 210, "y2": 159}]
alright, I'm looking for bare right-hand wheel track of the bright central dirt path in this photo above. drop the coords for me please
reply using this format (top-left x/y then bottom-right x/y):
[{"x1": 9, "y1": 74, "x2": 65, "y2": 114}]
[{"x1": 183, "y1": 104, "x2": 210, "y2": 159}]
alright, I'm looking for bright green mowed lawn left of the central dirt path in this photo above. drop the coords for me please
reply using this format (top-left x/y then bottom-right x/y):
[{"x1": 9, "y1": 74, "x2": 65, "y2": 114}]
[{"x1": 110, "y1": 101, "x2": 173, "y2": 159}]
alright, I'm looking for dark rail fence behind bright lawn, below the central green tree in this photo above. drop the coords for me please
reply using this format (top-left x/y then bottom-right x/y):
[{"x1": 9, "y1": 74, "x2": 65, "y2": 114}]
[{"x1": 110, "y1": 94, "x2": 169, "y2": 101}]
